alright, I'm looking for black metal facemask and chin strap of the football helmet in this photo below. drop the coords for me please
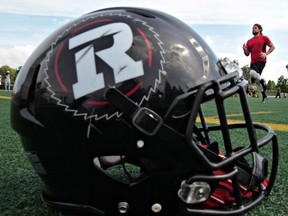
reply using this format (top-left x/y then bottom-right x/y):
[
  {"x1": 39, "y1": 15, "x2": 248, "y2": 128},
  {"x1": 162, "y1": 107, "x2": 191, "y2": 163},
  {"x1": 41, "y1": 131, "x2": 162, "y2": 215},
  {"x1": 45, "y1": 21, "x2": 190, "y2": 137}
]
[{"x1": 106, "y1": 68, "x2": 278, "y2": 215}]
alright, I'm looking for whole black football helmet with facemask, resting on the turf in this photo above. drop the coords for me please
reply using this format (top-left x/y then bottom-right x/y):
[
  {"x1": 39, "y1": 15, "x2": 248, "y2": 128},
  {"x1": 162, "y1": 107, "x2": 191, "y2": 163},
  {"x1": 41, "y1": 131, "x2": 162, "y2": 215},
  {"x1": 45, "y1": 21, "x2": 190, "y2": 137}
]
[{"x1": 11, "y1": 8, "x2": 278, "y2": 216}]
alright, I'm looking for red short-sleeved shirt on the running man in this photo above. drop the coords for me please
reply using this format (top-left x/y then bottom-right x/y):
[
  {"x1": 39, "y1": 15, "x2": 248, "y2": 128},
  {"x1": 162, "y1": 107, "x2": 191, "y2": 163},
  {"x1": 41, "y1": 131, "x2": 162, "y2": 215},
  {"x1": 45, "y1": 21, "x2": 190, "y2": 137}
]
[{"x1": 246, "y1": 35, "x2": 271, "y2": 64}]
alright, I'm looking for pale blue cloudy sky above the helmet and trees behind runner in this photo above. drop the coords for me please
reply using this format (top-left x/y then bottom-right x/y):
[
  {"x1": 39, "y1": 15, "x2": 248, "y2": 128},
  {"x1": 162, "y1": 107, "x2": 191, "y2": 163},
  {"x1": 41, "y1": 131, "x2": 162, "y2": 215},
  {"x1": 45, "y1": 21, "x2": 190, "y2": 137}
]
[{"x1": 0, "y1": 0, "x2": 288, "y2": 82}]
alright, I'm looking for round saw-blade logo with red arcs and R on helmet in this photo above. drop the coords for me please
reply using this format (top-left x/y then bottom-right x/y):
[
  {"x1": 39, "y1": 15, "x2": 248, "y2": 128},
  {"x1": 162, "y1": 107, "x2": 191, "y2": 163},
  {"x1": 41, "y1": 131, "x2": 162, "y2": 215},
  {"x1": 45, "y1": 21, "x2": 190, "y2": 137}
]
[{"x1": 43, "y1": 12, "x2": 166, "y2": 121}]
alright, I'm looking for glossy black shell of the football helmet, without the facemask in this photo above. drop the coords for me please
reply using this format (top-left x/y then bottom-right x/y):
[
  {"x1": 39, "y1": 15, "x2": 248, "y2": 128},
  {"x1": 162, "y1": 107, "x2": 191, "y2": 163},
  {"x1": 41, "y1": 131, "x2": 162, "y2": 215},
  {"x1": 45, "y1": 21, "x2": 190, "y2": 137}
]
[{"x1": 11, "y1": 8, "x2": 232, "y2": 215}]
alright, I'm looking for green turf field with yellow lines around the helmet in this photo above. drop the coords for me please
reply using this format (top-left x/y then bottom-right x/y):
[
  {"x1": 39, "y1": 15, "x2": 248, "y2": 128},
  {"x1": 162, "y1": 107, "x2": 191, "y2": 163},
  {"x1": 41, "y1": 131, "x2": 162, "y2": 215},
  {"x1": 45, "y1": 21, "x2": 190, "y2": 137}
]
[{"x1": 0, "y1": 91, "x2": 288, "y2": 216}]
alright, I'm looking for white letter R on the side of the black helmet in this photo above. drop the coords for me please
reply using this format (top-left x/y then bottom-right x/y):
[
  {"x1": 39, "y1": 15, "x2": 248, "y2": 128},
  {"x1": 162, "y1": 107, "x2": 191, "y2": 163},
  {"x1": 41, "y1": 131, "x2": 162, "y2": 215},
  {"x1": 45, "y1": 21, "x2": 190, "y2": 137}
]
[{"x1": 69, "y1": 23, "x2": 144, "y2": 99}]
